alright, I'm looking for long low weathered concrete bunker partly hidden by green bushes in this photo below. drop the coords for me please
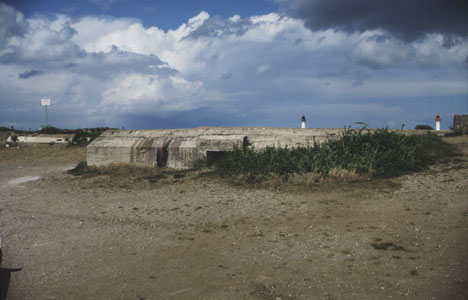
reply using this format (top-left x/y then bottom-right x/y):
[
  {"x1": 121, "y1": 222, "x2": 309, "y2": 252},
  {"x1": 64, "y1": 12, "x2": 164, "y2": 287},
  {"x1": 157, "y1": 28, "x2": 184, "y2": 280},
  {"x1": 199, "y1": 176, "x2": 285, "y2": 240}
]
[{"x1": 87, "y1": 127, "x2": 452, "y2": 169}]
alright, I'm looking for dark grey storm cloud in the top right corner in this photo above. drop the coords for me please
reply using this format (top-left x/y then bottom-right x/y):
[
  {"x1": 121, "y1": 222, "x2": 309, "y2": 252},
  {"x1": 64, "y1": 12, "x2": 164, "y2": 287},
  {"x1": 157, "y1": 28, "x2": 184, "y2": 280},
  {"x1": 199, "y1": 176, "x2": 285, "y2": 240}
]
[{"x1": 279, "y1": 0, "x2": 468, "y2": 42}]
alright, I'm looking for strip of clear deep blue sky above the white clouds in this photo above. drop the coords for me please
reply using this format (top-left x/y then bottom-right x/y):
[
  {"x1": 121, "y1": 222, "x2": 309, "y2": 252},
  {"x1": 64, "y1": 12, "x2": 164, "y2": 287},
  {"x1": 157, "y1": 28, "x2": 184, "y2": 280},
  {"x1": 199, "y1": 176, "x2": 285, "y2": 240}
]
[{"x1": 5, "y1": 0, "x2": 279, "y2": 30}]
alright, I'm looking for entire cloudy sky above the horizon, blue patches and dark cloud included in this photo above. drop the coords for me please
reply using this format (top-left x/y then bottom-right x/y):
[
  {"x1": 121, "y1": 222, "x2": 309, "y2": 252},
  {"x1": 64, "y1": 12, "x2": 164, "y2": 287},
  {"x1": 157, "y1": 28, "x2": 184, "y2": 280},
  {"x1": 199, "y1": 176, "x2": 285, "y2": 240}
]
[{"x1": 0, "y1": 0, "x2": 468, "y2": 130}]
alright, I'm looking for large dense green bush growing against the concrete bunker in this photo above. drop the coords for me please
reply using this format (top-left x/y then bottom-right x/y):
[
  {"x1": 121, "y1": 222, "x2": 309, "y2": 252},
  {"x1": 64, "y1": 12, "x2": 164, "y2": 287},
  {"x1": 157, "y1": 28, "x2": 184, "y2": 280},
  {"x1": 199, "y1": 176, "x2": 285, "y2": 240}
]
[{"x1": 215, "y1": 128, "x2": 455, "y2": 182}]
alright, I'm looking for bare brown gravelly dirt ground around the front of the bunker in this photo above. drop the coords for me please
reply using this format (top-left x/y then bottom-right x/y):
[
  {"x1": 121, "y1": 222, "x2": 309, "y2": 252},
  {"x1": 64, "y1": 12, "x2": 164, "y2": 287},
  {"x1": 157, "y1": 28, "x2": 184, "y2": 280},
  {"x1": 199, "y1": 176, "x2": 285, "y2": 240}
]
[{"x1": 0, "y1": 136, "x2": 468, "y2": 300}]
